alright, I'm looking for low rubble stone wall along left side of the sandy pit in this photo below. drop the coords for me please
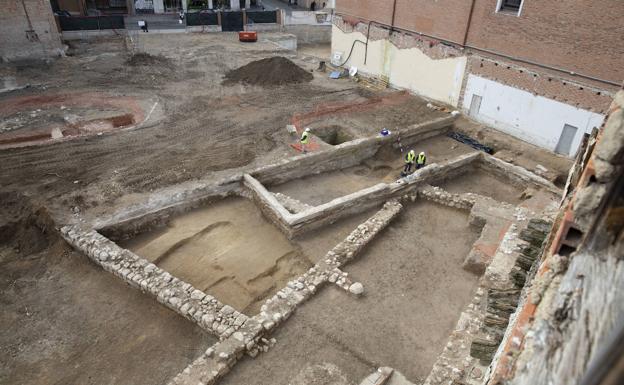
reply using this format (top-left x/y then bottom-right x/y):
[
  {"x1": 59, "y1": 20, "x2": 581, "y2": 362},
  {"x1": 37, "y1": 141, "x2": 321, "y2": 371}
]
[{"x1": 61, "y1": 226, "x2": 248, "y2": 339}]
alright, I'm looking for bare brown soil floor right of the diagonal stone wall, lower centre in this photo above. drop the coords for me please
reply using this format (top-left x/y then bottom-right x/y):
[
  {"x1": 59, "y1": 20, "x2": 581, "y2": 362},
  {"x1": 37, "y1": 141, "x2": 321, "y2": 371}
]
[{"x1": 222, "y1": 203, "x2": 478, "y2": 385}]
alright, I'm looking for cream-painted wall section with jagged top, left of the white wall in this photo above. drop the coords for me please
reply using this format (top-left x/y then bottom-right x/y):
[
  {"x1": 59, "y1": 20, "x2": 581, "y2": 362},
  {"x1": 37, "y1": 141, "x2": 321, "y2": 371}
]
[{"x1": 332, "y1": 25, "x2": 466, "y2": 106}]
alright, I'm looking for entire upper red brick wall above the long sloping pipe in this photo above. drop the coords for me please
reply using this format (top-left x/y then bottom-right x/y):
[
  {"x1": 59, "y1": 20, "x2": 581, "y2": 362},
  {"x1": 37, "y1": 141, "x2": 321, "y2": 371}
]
[{"x1": 336, "y1": 0, "x2": 624, "y2": 83}]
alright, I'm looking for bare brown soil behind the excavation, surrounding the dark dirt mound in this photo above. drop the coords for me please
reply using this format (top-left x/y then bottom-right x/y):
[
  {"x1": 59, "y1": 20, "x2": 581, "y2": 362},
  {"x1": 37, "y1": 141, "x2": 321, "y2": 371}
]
[{"x1": 0, "y1": 34, "x2": 448, "y2": 225}]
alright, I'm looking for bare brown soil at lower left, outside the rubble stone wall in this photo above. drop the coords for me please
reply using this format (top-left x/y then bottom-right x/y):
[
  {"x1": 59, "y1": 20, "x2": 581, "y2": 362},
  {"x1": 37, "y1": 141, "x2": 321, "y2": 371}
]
[{"x1": 0, "y1": 195, "x2": 216, "y2": 385}]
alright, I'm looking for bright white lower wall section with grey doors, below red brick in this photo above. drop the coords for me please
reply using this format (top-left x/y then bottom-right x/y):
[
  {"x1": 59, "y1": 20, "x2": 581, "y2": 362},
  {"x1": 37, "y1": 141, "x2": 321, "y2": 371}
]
[{"x1": 462, "y1": 74, "x2": 604, "y2": 156}]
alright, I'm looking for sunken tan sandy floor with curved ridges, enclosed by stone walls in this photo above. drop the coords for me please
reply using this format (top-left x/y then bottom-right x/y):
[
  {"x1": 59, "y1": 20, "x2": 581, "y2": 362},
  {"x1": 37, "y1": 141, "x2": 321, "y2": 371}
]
[{"x1": 118, "y1": 197, "x2": 312, "y2": 314}]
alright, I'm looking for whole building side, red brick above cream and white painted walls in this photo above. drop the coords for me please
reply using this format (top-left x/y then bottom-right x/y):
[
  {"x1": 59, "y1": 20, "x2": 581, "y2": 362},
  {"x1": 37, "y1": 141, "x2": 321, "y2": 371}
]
[{"x1": 332, "y1": 0, "x2": 624, "y2": 156}]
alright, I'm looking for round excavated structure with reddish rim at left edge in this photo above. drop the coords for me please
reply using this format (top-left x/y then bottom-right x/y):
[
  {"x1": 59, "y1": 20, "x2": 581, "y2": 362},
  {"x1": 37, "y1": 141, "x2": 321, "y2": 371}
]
[{"x1": 0, "y1": 93, "x2": 156, "y2": 148}]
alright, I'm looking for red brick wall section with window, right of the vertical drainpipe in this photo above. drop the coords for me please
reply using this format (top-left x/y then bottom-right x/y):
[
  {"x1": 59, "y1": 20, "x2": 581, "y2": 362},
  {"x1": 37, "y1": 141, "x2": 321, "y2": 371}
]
[{"x1": 468, "y1": 0, "x2": 624, "y2": 83}]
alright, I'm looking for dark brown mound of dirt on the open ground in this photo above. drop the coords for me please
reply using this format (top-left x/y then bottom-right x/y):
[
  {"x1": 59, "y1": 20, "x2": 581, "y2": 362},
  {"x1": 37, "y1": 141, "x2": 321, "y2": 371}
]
[{"x1": 223, "y1": 56, "x2": 314, "y2": 86}]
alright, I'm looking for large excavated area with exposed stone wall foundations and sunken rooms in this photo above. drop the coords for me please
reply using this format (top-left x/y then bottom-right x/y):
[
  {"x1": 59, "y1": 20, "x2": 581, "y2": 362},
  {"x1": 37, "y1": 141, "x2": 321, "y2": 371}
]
[{"x1": 39, "y1": 113, "x2": 556, "y2": 385}]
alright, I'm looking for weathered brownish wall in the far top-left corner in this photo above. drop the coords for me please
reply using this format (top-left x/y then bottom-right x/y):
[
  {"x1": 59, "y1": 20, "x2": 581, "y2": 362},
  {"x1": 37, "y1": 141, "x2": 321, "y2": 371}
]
[{"x1": 0, "y1": 0, "x2": 63, "y2": 60}]
